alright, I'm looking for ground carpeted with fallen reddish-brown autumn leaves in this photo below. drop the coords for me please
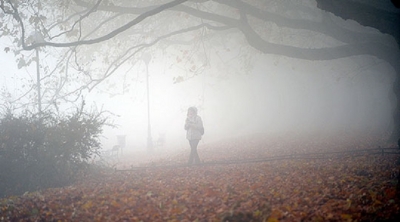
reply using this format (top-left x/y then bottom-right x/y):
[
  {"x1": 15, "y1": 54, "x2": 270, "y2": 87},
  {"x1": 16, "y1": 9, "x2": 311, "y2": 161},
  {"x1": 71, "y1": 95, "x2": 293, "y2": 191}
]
[{"x1": 0, "y1": 133, "x2": 400, "y2": 221}]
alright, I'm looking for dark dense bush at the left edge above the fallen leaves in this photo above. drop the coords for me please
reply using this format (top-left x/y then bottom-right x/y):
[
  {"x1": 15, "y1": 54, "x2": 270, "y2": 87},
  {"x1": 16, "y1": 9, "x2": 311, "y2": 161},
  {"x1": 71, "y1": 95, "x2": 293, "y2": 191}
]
[{"x1": 0, "y1": 110, "x2": 105, "y2": 197}]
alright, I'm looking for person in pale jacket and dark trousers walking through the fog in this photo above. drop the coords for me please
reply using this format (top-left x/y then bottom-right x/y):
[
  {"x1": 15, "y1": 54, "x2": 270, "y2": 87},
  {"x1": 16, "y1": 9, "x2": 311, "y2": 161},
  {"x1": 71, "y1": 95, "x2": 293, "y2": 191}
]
[{"x1": 184, "y1": 106, "x2": 204, "y2": 165}]
